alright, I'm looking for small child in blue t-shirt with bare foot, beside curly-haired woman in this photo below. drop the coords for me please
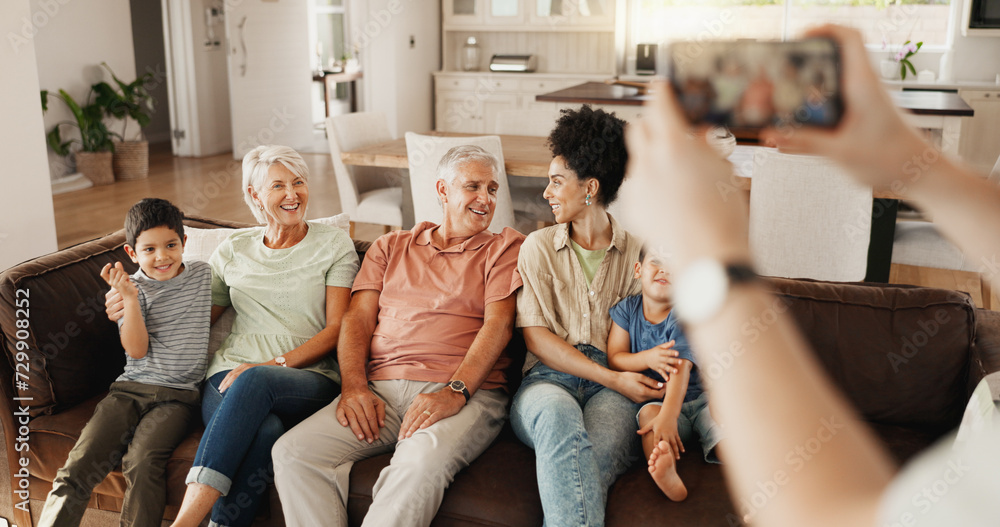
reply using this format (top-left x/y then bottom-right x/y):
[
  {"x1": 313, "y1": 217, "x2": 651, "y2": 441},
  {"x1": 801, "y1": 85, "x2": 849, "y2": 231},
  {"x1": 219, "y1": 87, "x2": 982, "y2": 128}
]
[{"x1": 608, "y1": 249, "x2": 721, "y2": 501}]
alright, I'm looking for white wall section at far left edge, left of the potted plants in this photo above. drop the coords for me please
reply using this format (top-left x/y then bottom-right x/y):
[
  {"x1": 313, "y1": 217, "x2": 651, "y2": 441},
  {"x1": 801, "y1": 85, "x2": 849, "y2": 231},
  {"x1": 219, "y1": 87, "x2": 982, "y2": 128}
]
[{"x1": 0, "y1": 0, "x2": 56, "y2": 269}]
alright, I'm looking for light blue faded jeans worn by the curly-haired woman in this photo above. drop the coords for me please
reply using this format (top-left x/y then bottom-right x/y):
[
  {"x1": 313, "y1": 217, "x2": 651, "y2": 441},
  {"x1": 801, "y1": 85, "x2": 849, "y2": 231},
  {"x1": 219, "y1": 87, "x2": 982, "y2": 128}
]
[{"x1": 510, "y1": 344, "x2": 639, "y2": 527}]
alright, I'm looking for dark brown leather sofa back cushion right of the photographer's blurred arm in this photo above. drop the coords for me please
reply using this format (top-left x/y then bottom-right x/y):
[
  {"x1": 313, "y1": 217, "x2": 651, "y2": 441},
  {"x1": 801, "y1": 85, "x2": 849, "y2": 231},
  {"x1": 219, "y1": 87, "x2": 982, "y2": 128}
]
[{"x1": 764, "y1": 279, "x2": 976, "y2": 434}]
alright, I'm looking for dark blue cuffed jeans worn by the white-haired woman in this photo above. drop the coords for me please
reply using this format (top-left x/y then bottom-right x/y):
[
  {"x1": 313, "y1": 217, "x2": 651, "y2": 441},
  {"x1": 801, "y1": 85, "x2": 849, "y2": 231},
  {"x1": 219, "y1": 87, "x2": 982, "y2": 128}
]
[{"x1": 187, "y1": 366, "x2": 340, "y2": 527}]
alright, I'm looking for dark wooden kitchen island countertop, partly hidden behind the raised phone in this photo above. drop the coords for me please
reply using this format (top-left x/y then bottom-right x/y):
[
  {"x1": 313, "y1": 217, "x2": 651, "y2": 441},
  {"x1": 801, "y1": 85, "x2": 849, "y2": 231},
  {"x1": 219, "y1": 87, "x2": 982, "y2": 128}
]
[{"x1": 535, "y1": 82, "x2": 973, "y2": 117}]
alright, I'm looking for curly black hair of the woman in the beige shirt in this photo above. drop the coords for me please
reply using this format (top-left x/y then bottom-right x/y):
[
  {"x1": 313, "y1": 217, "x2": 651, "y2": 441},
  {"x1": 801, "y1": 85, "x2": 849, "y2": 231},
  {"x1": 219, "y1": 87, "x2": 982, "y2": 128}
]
[{"x1": 548, "y1": 104, "x2": 628, "y2": 207}]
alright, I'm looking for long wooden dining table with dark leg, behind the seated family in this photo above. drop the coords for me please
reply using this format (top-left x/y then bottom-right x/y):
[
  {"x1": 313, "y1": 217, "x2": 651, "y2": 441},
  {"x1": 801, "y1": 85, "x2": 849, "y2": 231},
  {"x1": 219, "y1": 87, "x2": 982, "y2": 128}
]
[{"x1": 340, "y1": 132, "x2": 899, "y2": 282}]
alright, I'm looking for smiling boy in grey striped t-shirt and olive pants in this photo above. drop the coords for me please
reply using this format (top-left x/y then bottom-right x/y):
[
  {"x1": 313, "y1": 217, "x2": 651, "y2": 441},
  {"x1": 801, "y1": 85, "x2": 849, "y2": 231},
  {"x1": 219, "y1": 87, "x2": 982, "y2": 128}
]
[{"x1": 38, "y1": 198, "x2": 212, "y2": 526}]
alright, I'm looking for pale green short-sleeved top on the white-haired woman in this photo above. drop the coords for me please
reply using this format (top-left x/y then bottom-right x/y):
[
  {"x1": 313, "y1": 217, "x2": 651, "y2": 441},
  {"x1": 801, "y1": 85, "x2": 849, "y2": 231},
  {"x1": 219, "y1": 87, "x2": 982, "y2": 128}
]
[{"x1": 206, "y1": 223, "x2": 358, "y2": 384}]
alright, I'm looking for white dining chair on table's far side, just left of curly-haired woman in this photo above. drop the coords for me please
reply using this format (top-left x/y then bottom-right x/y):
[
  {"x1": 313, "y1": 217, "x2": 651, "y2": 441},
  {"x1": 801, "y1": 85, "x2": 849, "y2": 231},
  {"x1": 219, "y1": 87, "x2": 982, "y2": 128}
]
[{"x1": 495, "y1": 109, "x2": 560, "y2": 223}]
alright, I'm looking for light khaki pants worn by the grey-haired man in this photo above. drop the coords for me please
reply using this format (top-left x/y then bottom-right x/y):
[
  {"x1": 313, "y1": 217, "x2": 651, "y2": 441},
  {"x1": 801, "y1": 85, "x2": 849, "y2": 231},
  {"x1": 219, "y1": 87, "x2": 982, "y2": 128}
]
[{"x1": 272, "y1": 380, "x2": 507, "y2": 527}]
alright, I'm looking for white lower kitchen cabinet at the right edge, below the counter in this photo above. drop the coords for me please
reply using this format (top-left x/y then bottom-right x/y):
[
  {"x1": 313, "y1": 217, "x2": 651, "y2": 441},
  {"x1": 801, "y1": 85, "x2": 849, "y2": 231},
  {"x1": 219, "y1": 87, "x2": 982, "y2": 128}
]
[{"x1": 958, "y1": 89, "x2": 1000, "y2": 172}]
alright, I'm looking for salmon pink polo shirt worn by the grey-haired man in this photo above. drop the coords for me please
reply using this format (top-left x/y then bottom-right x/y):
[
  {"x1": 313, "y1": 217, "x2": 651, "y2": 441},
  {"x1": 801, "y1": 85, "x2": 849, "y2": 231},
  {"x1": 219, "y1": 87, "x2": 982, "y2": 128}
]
[{"x1": 352, "y1": 222, "x2": 524, "y2": 389}]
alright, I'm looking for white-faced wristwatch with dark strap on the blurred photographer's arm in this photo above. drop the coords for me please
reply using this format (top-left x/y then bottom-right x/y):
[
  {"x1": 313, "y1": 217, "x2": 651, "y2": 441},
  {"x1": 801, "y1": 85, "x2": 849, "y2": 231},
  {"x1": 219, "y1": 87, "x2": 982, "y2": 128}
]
[{"x1": 673, "y1": 258, "x2": 760, "y2": 324}]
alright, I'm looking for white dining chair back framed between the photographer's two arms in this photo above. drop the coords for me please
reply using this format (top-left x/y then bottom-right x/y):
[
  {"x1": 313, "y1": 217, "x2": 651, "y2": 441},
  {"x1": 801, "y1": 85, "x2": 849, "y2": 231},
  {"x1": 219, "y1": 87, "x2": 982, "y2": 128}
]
[{"x1": 748, "y1": 150, "x2": 872, "y2": 282}]
